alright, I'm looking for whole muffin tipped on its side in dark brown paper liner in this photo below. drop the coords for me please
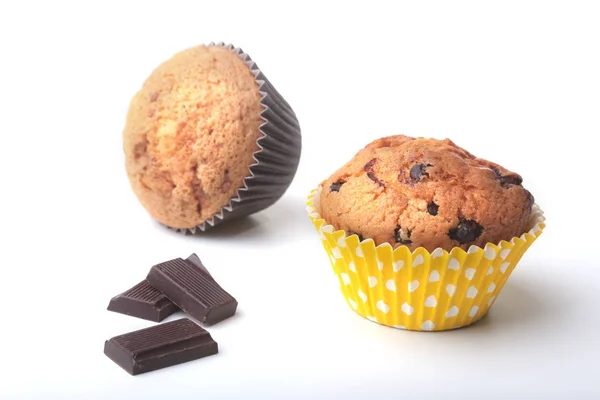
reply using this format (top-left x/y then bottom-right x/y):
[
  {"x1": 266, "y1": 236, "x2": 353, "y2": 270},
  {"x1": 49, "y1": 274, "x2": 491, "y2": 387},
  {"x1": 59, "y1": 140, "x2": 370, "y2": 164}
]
[{"x1": 123, "y1": 45, "x2": 301, "y2": 233}]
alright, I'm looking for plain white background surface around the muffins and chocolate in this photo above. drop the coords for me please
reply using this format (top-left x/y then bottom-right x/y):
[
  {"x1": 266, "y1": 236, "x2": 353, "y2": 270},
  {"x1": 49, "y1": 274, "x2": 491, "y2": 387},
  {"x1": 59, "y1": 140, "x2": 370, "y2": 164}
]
[{"x1": 0, "y1": 0, "x2": 600, "y2": 399}]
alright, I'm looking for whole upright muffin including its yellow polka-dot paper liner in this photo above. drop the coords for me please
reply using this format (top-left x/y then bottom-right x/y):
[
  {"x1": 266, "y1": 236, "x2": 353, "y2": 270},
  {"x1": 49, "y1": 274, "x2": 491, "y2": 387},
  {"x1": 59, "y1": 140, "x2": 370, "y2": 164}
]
[{"x1": 307, "y1": 135, "x2": 545, "y2": 331}]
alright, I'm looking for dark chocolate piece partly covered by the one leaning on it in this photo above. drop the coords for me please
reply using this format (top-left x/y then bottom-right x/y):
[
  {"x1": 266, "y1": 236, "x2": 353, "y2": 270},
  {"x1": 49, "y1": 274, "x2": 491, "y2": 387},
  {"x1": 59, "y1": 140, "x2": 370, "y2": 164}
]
[{"x1": 108, "y1": 280, "x2": 179, "y2": 322}]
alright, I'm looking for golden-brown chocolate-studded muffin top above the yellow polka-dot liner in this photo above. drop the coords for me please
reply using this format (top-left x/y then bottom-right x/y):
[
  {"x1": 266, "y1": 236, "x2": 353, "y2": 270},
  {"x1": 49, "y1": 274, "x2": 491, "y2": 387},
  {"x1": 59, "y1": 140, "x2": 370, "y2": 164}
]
[{"x1": 320, "y1": 135, "x2": 534, "y2": 251}]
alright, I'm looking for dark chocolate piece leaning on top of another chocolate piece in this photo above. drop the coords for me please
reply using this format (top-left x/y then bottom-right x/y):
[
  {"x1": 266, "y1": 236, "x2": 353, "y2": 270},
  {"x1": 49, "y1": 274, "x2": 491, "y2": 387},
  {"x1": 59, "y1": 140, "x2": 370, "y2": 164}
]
[{"x1": 146, "y1": 258, "x2": 238, "y2": 324}]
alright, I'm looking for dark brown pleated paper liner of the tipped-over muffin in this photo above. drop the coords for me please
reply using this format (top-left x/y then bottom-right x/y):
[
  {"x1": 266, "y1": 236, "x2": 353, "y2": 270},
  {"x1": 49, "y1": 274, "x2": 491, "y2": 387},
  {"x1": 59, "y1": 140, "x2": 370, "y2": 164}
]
[{"x1": 172, "y1": 43, "x2": 302, "y2": 234}]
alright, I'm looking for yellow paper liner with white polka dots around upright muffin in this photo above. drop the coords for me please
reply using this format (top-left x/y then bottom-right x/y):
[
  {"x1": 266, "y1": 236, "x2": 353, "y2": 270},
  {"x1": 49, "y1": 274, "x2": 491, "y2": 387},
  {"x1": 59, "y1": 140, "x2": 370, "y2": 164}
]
[{"x1": 306, "y1": 188, "x2": 546, "y2": 331}]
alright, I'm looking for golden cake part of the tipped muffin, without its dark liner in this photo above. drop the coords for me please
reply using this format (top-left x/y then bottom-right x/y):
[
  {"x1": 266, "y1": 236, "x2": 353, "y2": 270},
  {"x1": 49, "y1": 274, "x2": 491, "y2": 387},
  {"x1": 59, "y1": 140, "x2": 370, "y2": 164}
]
[{"x1": 123, "y1": 46, "x2": 263, "y2": 228}]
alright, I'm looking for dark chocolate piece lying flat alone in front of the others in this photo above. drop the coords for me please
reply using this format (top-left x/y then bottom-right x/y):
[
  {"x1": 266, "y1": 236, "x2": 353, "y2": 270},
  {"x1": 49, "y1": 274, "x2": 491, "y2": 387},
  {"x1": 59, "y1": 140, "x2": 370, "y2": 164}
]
[{"x1": 104, "y1": 318, "x2": 219, "y2": 375}]
